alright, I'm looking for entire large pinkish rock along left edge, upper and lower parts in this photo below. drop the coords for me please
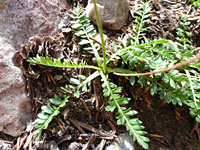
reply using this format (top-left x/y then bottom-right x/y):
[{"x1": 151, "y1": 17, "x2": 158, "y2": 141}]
[{"x1": 0, "y1": 0, "x2": 70, "y2": 136}]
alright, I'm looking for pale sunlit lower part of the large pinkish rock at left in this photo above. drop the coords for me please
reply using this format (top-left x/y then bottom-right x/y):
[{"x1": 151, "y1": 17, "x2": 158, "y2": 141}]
[{"x1": 0, "y1": 38, "x2": 31, "y2": 136}]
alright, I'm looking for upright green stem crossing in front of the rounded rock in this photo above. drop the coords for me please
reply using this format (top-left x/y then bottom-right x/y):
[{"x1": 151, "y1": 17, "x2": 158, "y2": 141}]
[{"x1": 93, "y1": 0, "x2": 107, "y2": 73}]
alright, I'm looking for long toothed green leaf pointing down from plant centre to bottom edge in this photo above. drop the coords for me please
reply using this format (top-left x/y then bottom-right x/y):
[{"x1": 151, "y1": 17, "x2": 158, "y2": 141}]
[{"x1": 100, "y1": 72, "x2": 149, "y2": 149}]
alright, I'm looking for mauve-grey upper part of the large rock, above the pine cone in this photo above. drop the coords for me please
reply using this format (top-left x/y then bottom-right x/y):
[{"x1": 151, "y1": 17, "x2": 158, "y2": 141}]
[{"x1": 0, "y1": 0, "x2": 71, "y2": 49}]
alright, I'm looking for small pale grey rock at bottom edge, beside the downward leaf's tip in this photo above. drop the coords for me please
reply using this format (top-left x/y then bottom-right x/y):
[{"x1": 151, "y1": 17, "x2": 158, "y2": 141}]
[{"x1": 105, "y1": 132, "x2": 135, "y2": 150}]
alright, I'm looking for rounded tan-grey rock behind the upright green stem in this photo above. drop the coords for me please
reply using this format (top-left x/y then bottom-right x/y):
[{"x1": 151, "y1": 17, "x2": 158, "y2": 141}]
[{"x1": 86, "y1": 0, "x2": 129, "y2": 30}]
